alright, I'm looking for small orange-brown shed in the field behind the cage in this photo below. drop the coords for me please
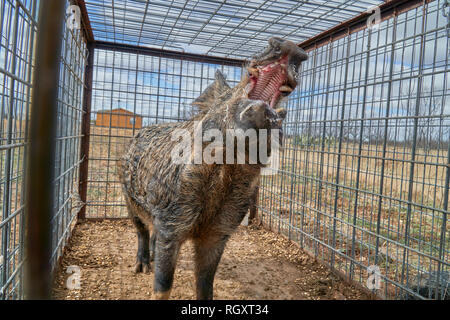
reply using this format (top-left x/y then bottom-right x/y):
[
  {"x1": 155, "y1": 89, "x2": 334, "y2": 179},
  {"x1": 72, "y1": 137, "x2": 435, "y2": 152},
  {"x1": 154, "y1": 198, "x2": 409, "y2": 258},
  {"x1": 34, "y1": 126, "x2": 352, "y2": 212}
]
[{"x1": 95, "y1": 108, "x2": 142, "y2": 129}]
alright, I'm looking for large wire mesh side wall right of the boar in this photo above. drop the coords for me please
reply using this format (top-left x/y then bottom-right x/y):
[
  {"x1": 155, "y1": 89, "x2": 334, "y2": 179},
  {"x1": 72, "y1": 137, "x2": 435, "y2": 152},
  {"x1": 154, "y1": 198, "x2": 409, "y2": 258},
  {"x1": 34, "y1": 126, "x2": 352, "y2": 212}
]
[{"x1": 258, "y1": 1, "x2": 450, "y2": 299}]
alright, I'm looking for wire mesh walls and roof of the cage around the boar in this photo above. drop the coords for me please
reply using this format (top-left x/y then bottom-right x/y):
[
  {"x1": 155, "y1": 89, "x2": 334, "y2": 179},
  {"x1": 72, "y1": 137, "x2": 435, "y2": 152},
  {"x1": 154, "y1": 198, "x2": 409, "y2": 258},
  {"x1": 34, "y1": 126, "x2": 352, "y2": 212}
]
[{"x1": 0, "y1": 0, "x2": 450, "y2": 299}]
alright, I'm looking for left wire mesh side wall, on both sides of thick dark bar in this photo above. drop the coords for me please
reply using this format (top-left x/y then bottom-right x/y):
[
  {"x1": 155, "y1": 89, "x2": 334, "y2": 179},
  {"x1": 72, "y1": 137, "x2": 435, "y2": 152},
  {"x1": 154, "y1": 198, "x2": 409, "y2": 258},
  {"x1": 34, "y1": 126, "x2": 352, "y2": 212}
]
[{"x1": 0, "y1": 0, "x2": 85, "y2": 299}]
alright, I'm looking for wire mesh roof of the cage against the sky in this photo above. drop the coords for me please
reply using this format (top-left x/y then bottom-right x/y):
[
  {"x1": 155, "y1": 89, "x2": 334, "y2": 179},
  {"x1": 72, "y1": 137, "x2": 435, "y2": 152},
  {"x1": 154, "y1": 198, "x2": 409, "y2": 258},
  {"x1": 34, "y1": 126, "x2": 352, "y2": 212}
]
[{"x1": 85, "y1": 0, "x2": 384, "y2": 59}]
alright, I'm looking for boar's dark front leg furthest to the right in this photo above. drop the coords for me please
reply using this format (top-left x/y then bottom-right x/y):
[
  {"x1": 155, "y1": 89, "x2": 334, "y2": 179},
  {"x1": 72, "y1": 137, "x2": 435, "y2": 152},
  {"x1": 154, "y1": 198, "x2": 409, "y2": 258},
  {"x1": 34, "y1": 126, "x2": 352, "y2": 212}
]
[{"x1": 194, "y1": 236, "x2": 229, "y2": 300}]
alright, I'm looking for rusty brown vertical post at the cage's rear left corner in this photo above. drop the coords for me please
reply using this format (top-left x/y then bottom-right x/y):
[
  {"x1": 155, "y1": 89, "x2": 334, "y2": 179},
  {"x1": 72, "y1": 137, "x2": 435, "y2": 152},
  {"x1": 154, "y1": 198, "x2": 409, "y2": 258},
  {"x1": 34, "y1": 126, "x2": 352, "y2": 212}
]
[{"x1": 78, "y1": 42, "x2": 94, "y2": 219}]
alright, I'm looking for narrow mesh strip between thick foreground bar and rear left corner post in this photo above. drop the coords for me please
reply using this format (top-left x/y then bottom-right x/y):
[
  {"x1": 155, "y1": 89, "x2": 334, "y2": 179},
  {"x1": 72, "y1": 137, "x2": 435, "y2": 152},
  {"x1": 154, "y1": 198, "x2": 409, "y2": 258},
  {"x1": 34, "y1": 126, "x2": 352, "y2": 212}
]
[{"x1": 52, "y1": 3, "x2": 87, "y2": 266}]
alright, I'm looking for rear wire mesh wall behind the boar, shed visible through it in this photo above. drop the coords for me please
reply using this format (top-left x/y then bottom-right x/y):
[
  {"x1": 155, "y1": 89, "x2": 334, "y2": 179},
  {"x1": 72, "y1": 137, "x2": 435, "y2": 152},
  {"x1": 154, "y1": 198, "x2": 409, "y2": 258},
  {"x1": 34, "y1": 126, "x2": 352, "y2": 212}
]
[{"x1": 86, "y1": 49, "x2": 242, "y2": 218}]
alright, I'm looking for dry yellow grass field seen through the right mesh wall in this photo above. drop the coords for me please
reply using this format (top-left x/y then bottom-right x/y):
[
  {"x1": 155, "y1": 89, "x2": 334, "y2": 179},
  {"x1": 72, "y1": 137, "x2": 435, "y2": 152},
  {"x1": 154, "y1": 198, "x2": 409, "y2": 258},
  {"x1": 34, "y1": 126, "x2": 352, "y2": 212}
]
[{"x1": 260, "y1": 141, "x2": 450, "y2": 298}]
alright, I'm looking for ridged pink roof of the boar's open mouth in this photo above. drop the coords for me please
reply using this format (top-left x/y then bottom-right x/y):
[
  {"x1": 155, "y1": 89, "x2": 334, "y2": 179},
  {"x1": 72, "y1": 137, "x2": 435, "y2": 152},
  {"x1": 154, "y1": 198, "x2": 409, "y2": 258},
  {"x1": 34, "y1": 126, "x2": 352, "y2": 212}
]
[{"x1": 249, "y1": 56, "x2": 288, "y2": 108}]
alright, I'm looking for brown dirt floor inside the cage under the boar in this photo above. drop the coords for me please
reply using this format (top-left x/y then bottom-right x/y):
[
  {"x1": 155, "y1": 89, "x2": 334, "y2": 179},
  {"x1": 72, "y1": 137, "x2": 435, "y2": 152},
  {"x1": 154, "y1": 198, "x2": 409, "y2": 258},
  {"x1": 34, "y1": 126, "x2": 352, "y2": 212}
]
[{"x1": 53, "y1": 220, "x2": 368, "y2": 300}]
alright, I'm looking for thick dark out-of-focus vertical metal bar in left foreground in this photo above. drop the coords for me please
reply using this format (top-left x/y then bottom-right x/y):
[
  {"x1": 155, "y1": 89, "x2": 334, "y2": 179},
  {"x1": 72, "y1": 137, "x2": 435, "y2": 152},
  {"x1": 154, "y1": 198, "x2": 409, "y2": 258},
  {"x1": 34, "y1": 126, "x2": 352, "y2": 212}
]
[{"x1": 26, "y1": 0, "x2": 65, "y2": 299}]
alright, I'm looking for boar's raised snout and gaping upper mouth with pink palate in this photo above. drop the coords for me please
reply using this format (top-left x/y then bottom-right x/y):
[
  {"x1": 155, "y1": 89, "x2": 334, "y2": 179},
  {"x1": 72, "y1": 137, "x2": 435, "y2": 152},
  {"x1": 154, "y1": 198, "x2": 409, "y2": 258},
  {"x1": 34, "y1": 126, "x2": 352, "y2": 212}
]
[{"x1": 246, "y1": 38, "x2": 308, "y2": 108}]
